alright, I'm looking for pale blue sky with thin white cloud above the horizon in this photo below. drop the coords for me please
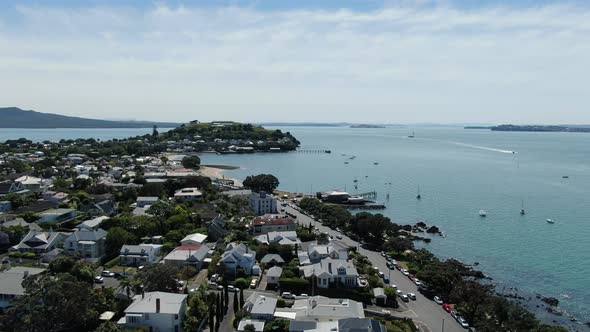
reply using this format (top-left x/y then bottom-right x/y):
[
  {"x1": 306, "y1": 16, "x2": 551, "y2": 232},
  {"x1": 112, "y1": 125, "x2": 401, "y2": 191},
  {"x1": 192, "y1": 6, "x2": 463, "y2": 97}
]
[{"x1": 0, "y1": 0, "x2": 590, "y2": 124}]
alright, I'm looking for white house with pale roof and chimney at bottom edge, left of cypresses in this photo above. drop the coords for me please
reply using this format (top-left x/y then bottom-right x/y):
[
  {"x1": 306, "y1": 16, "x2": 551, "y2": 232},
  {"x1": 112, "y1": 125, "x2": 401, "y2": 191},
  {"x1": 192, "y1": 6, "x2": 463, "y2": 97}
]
[{"x1": 117, "y1": 292, "x2": 187, "y2": 332}]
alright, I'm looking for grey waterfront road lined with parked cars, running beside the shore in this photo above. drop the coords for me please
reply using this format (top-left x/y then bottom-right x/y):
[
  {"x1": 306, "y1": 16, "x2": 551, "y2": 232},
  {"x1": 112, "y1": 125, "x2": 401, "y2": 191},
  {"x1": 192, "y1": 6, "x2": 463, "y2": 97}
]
[{"x1": 285, "y1": 205, "x2": 466, "y2": 332}]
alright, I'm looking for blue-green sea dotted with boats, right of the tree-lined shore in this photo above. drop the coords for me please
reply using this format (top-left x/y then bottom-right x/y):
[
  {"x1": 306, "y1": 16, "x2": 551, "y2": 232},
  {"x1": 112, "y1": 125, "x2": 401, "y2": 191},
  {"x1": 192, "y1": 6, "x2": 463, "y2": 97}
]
[{"x1": 202, "y1": 127, "x2": 590, "y2": 329}]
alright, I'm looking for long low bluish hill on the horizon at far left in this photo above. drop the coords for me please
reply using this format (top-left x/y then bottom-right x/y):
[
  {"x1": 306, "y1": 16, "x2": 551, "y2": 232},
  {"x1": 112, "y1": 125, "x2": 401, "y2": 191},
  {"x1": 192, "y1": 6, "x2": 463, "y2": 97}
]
[{"x1": 0, "y1": 107, "x2": 181, "y2": 128}]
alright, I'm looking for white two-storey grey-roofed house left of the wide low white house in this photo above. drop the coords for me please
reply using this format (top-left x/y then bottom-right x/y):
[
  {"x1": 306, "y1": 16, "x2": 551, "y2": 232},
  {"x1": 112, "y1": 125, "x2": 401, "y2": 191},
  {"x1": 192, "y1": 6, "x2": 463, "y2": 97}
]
[{"x1": 63, "y1": 228, "x2": 107, "y2": 263}]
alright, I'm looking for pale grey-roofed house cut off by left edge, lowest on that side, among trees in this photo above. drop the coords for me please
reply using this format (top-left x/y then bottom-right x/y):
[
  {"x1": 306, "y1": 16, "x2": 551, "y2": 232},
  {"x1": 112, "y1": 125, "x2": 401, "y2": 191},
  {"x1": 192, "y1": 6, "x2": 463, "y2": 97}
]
[{"x1": 0, "y1": 266, "x2": 45, "y2": 309}]
